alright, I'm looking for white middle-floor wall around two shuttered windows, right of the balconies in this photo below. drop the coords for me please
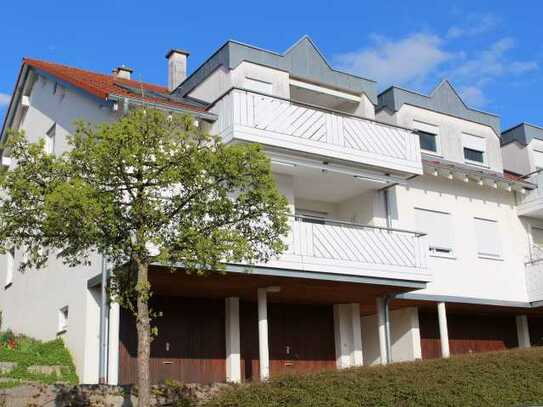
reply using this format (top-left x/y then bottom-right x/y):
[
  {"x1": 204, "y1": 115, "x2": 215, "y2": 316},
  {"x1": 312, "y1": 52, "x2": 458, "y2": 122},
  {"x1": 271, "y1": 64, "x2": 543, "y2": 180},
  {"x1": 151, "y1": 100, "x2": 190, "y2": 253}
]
[{"x1": 393, "y1": 175, "x2": 528, "y2": 301}]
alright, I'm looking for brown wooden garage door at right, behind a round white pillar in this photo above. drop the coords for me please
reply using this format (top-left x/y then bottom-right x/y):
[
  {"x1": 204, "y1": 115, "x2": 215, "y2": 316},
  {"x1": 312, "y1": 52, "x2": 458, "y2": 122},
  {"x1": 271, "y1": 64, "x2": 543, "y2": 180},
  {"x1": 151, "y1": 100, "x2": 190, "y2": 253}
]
[{"x1": 419, "y1": 312, "x2": 518, "y2": 359}]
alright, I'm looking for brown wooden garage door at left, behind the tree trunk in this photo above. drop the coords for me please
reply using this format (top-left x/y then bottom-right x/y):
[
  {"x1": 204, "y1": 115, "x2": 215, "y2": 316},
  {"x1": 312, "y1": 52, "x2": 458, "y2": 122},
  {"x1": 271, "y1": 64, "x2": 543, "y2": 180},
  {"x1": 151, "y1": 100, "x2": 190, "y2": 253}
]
[{"x1": 119, "y1": 297, "x2": 226, "y2": 384}]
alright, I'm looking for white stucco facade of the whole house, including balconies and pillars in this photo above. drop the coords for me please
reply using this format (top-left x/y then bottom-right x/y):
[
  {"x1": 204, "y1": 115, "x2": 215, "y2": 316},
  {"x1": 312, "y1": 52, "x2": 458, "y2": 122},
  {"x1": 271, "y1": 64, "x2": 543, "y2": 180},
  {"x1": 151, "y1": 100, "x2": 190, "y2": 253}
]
[{"x1": 0, "y1": 36, "x2": 543, "y2": 383}]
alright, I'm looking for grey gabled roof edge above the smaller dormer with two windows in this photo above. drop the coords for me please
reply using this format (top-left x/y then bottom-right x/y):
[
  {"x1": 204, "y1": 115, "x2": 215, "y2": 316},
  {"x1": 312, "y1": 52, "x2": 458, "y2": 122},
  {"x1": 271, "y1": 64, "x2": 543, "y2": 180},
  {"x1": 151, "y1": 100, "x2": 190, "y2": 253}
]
[{"x1": 378, "y1": 80, "x2": 500, "y2": 136}]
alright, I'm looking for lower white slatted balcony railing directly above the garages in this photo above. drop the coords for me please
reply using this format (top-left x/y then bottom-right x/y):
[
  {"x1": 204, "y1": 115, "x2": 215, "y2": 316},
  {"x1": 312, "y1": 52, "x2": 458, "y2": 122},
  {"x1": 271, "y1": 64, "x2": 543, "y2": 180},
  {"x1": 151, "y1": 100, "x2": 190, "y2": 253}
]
[{"x1": 267, "y1": 216, "x2": 431, "y2": 282}]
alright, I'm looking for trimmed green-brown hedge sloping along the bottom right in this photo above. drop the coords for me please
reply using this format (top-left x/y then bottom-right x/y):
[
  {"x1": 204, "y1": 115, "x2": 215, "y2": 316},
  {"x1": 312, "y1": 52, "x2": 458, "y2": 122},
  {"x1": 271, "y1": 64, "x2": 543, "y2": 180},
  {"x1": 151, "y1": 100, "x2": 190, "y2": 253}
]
[{"x1": 206, "y1": 348, "x2": 543, "y2": 407}]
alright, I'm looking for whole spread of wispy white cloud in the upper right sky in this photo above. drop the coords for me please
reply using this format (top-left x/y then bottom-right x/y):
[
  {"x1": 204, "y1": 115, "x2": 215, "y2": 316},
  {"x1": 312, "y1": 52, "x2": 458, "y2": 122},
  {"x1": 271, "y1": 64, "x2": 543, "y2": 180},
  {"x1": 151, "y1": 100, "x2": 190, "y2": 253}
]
[{"x1": 335, "y1": 24, "x2": 539, "y2": 107}]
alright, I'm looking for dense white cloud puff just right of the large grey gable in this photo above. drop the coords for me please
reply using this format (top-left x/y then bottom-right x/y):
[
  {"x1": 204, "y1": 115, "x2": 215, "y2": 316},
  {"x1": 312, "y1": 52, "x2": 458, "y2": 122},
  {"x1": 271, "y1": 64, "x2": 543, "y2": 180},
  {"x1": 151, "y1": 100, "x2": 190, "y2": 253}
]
[{"x1": 336, "y1": 33, "x2": 451, "y2": 84}]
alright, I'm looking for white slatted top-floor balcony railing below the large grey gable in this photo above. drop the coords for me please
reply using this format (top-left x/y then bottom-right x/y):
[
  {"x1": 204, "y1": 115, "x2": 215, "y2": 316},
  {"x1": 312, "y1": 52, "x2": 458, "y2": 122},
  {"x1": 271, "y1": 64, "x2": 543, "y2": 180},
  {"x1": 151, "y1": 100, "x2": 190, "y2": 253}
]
[{"x1": 210, "y1": 88, "x2": 422, "y2": 175}]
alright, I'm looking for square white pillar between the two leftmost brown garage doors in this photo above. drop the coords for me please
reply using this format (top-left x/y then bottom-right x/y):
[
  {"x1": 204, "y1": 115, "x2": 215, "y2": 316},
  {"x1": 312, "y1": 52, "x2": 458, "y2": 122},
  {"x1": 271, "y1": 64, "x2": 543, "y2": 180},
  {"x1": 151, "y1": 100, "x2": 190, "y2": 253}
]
[{"x1": 225, "y1": 297, "x2": 241, "y2": 383}]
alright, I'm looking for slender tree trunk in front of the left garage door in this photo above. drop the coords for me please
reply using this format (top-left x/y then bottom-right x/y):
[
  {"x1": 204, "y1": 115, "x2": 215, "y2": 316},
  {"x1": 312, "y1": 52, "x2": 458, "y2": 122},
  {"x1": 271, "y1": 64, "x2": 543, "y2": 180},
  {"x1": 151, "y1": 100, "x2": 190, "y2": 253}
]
[{"x1": 134, "y1": 256, "x2": 151, "y2": 407}]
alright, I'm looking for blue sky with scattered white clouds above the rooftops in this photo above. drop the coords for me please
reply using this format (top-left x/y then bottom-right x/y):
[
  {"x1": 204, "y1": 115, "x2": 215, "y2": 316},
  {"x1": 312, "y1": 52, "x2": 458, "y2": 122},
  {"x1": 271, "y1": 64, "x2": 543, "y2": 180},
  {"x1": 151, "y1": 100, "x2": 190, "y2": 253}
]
[{"x1": 0, "y1": 0, "x2": 543, "y2": 129}]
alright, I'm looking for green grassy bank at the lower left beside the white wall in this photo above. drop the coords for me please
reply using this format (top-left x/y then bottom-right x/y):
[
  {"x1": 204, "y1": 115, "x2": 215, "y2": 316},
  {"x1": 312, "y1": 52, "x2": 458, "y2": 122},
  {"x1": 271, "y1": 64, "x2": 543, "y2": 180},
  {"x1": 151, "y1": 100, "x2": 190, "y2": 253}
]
[{"x1": 0, "y1": 332, "x2": 78, "y2": 388}]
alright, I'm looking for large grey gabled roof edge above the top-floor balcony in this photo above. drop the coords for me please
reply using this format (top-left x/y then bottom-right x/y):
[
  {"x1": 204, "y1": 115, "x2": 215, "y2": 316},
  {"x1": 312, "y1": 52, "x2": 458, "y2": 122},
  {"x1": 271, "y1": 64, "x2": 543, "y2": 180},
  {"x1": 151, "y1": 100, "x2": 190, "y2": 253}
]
[{"x1": 174, "y1": 36, "x2": 377, "y2": 104}]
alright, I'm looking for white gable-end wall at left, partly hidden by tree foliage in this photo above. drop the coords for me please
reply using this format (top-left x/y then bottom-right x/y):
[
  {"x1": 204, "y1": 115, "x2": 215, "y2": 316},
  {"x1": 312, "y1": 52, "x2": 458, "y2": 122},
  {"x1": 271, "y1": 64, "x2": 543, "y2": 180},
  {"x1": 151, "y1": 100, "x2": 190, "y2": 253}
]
[{"x1": 0, "y1": 73, "x2": 115, "y2": 383}]
